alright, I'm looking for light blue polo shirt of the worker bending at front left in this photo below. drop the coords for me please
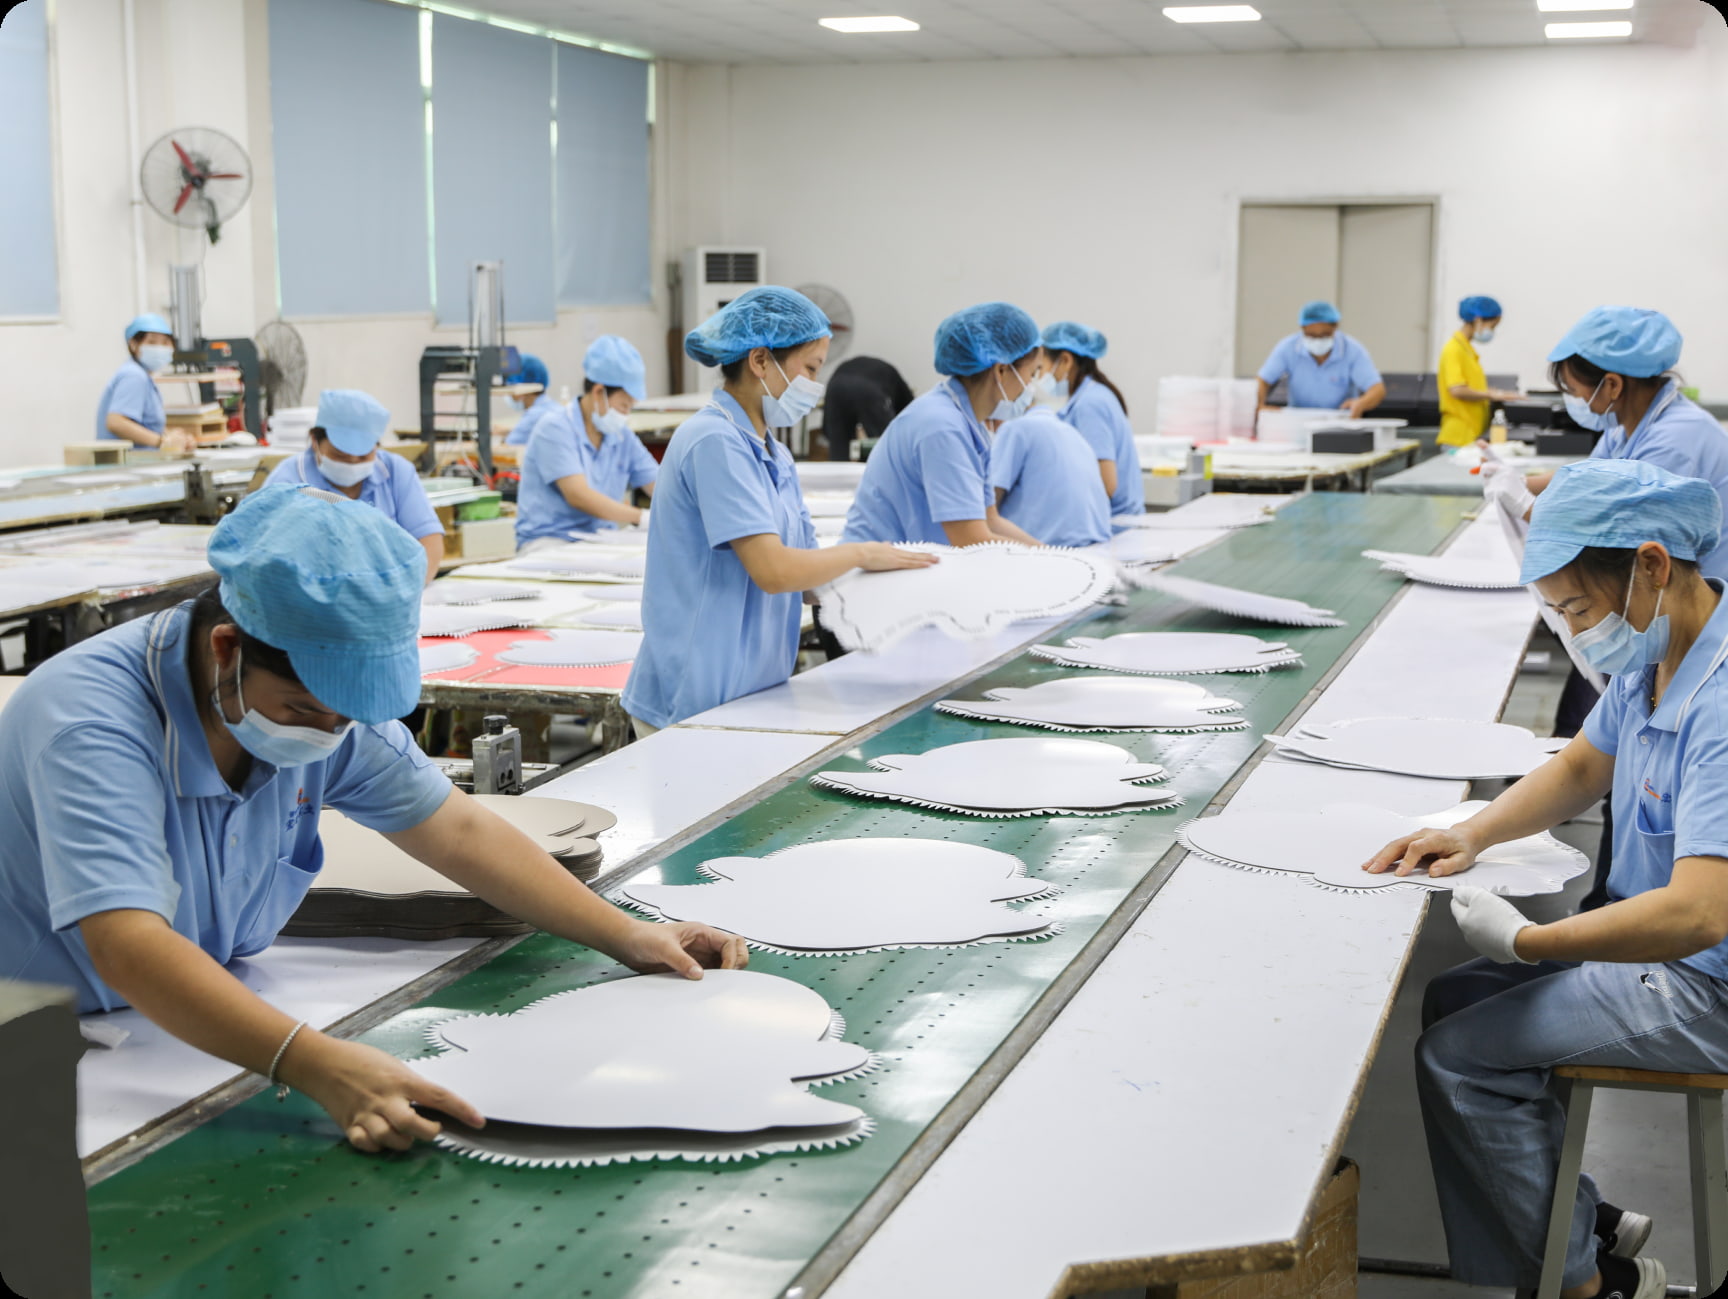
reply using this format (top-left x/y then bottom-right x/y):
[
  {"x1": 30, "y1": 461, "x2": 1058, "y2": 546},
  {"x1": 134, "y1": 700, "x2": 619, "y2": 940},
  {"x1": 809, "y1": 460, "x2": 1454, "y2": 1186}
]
[{"x1": 0, "y1": 603, "x2": 451, "y2": 1011}]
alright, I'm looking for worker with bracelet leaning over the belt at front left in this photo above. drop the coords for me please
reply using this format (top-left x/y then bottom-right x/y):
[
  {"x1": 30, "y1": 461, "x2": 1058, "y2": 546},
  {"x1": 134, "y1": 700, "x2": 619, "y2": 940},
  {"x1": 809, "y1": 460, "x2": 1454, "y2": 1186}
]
[{"x1": 0, "y1": 487, "x2": 745, "y2": 1150}]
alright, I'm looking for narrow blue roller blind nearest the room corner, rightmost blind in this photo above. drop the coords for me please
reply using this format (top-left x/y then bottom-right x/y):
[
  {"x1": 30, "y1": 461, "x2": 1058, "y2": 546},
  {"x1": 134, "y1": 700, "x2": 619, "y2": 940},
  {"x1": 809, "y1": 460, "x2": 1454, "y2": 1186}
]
[{"x1": 558, "y1": 45, "x2": 650, "y2": 306}]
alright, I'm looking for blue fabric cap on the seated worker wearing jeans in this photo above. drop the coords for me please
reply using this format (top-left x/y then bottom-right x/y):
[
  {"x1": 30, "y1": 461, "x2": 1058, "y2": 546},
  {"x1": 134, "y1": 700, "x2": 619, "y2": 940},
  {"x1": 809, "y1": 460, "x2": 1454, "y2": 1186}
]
[{"x1": 1519, "y1": 459, "x2": 1723, "y2": 582}]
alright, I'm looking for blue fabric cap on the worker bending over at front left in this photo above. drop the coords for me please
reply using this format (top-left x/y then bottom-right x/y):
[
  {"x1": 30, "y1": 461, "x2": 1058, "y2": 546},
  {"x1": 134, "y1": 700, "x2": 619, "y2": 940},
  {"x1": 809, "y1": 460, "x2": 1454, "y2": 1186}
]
[{"x1": 209, "y1": 485, "x2": 427, "y2": 724}]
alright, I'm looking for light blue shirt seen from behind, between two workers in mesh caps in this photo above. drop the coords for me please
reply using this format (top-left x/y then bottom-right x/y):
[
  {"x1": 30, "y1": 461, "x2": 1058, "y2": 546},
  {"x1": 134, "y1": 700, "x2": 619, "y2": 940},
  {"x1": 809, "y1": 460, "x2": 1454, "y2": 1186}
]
[{"x1": 990, "y1": 408, "x2": 1111, "y2": 546}]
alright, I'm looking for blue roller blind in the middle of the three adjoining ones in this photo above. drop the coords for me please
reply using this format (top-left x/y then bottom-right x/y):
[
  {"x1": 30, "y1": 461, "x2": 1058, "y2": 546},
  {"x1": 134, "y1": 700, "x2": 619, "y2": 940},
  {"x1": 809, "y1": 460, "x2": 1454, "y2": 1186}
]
[{"x1": 432, "y1": 14, "x2": 558, "y2": 325}]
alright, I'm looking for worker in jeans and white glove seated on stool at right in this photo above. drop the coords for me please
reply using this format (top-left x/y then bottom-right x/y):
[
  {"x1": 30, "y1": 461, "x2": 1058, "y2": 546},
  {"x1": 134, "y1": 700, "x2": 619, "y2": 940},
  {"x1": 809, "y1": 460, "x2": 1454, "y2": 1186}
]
[{"x1": 1367, "y1": 459, "x2": 1728, "y2": 1299}]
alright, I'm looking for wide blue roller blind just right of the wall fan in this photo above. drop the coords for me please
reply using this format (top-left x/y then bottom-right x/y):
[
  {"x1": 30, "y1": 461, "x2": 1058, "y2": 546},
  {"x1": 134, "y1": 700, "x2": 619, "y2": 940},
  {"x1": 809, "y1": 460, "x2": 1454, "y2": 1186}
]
[{"x1": 270, "y1": 0, "x2": 432, "y2": 316}]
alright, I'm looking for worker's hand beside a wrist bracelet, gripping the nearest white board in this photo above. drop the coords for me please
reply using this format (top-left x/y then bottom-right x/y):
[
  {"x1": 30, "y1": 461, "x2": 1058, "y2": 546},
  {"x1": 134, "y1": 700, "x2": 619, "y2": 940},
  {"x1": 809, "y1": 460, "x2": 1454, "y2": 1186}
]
[{"x1": 276, "y1": 1028, "x2": 486, "y2": 1154}]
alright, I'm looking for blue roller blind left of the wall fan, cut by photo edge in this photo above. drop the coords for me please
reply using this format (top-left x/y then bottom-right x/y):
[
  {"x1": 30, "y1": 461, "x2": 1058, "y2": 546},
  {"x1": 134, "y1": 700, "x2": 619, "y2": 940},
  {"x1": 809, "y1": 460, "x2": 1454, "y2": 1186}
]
[{"x1": 0, "y1": 0, "x2": 60, "y2": 318}]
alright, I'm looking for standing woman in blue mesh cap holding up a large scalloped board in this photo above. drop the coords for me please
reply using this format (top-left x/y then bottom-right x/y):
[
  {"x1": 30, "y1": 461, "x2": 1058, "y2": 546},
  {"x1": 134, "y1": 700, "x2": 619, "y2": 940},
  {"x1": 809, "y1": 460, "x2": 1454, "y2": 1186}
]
[{"x1": 624, "y1": 285, "x2": 935, "y2": 734}]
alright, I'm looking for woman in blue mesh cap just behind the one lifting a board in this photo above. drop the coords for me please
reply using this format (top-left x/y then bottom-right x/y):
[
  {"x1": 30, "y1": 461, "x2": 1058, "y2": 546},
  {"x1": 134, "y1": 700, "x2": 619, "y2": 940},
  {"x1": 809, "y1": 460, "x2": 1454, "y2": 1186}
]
[{"x1": 840, "y1": 302, "x2": 1044, "y2": 546}]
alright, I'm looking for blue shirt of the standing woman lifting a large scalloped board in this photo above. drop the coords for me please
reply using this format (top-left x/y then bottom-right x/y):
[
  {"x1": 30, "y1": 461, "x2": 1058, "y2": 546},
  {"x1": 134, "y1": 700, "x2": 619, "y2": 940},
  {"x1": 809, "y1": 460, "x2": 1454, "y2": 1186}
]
[{"x1": 624, "y1": 389, "x2": 816, "y2": 727}]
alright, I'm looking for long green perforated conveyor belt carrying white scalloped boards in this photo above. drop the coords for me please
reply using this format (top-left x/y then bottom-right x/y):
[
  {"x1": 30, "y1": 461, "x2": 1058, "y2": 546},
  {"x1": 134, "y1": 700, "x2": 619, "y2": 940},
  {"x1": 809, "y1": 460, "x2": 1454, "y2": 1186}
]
[{"x1": 90, "y1": 494, "x2": 1471, "y2": 1299}]
